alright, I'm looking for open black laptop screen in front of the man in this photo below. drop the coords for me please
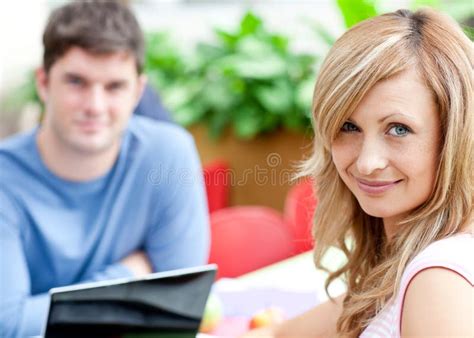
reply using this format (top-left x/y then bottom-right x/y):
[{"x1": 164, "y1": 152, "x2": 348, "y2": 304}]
[{"x1": 43, "y1": 265, "x2": 216, "y2": 338}]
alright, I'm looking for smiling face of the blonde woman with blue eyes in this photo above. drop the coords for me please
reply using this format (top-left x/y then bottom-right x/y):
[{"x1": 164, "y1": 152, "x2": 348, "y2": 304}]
[{"x1": 332, "y1": 70, "x2": 441, "y2": 235}]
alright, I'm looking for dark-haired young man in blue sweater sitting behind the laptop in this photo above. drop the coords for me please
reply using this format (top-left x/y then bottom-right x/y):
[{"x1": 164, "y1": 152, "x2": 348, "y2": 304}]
[{"x1": 0, "y1": 1, "x2": 209, "y2": 337}]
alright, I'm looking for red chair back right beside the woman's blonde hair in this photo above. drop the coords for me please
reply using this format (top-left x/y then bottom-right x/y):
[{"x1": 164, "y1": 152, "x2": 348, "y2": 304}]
[{"x1": 283, "y1": 179, "x2": 318, "y2": 253}]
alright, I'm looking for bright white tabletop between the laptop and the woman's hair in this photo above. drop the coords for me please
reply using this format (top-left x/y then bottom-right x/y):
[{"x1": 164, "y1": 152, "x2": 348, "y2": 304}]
[{"x1": 212, "y1": 249, "x2": 345, "y2": 337}]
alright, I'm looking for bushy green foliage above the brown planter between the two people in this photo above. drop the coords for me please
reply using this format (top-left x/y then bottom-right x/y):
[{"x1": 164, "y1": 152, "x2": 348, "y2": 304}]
[{"x1": 147, "y1": 12, "x2": 316, "y2": 139}]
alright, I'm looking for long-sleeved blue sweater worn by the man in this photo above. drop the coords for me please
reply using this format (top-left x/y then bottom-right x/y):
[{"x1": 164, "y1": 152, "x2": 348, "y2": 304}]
[{"x1": 0, "y1": 116, "x2": 209, "y2": 338}]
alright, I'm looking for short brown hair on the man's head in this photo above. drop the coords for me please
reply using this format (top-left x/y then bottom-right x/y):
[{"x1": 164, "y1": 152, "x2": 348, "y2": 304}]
[{"x1": 43, "y1": 0, "x2": 144, "y2": 73}]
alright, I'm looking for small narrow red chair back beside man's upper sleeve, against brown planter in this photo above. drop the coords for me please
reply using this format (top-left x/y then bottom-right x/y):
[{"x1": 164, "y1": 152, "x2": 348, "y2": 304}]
[{"x1": 204, "y1": 161, "x2": 231, "y2": 213}]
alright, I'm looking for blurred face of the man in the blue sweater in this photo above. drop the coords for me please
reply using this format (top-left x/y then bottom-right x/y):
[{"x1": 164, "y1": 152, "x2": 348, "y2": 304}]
[{"x1": 37, "y1": 47, "x2": 146, "y2": 154}]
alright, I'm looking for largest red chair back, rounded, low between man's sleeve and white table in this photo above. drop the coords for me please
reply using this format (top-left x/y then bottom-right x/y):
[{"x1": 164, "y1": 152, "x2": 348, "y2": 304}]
[{"x1": 209, "y1": 206, "x2": 295, "y2": 278}]
